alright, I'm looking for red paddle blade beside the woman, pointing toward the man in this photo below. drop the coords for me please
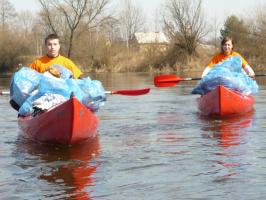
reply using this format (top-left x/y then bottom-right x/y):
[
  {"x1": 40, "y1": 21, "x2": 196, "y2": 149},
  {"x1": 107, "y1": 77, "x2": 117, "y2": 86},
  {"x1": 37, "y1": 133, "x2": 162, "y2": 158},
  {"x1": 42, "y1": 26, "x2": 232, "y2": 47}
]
[{"x1": 154, "y1": 74, "x2": 184, "y2": 87}]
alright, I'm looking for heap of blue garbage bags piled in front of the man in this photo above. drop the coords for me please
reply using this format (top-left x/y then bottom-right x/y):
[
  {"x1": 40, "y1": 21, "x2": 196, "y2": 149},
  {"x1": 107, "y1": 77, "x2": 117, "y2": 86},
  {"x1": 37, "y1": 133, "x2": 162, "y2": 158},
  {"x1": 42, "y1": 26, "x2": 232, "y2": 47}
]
[{"x1": 10, "y1": 67, "x2": 106, "y2": 116}]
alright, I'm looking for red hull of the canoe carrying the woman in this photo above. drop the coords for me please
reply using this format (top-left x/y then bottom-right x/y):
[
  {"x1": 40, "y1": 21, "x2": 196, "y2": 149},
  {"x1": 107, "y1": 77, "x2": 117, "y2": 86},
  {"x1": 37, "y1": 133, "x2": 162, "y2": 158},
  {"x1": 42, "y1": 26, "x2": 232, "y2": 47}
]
[{"x1": 197, "y1": 86, "x2": 254, "y2": 116}]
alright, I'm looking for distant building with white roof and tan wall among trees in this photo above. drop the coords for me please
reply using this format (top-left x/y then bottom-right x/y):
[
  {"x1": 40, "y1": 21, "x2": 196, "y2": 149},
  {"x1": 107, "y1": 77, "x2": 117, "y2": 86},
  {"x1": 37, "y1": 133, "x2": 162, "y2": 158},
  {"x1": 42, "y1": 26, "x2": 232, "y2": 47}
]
[{"x1": 134, "y1": 32, "x2": 169, "y2": 51}]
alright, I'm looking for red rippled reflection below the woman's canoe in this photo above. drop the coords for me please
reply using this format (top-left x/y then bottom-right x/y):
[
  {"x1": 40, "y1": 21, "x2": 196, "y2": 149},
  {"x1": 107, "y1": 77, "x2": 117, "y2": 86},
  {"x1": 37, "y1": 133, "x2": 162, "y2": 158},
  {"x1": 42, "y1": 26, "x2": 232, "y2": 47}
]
[{"x1": 200, "y1": 112, "x2": 254, "y2": 182}]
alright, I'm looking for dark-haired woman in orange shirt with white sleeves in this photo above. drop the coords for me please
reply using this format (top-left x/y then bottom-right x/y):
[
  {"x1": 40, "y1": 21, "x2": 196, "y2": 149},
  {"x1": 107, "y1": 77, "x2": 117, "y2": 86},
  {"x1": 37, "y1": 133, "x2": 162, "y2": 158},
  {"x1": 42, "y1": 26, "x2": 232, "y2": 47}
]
[{"x1": 202, "y1": 37, "x2": 255, "y2": 78}]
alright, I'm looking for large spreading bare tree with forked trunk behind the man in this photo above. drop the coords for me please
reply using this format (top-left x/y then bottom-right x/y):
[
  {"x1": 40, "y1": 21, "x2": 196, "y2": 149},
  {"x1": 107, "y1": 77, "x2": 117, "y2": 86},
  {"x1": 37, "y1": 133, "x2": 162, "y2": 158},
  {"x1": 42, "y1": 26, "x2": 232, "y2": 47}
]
[{"x1": 39, "y1": 0, "x2": 109, "y2": 57}]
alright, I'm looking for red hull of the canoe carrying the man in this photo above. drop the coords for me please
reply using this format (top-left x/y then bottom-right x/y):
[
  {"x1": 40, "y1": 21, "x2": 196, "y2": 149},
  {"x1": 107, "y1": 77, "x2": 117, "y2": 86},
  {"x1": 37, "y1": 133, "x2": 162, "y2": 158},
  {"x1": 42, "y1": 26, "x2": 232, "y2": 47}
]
[{"x1": 18, "y1": 98, "x2": 99, "y2": 144}]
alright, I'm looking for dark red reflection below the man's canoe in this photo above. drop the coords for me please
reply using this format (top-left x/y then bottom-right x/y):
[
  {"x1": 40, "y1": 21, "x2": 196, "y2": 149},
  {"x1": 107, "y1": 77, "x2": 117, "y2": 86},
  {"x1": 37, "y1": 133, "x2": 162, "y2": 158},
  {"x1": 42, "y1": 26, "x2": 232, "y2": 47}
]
[{"x1": 16, "y1": 136, "x2": 100, "y2": 199}]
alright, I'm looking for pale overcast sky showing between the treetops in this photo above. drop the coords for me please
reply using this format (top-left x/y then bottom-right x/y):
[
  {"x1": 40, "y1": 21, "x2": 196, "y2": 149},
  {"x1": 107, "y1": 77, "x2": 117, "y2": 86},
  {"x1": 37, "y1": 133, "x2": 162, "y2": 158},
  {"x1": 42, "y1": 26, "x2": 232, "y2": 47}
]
[{"x1": 10, "y1": 0, "x2": 266, "y2": 31}]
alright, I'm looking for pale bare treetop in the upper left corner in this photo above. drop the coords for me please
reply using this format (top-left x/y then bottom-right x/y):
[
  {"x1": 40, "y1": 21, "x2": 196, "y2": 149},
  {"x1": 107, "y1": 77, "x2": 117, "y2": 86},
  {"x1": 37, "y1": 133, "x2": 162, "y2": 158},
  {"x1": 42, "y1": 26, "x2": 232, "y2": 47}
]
[{"x1": 0, "y1": 0, "x2": 16, "y2": 29}]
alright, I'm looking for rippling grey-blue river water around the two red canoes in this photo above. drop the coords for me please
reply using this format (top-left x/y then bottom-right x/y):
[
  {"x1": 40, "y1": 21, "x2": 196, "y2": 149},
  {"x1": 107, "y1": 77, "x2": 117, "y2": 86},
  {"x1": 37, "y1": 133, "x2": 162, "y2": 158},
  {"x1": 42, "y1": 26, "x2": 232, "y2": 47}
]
[{"x1": 0, "y1": 74, "x2": 266, "y2": 200}]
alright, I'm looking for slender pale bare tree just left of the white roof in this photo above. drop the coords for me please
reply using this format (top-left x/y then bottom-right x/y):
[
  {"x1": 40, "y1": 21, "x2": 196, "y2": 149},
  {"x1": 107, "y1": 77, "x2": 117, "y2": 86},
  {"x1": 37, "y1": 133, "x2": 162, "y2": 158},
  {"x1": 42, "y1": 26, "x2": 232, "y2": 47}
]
[{"x1": 119, "y1": 0, "x2": 144, "y2": 47}]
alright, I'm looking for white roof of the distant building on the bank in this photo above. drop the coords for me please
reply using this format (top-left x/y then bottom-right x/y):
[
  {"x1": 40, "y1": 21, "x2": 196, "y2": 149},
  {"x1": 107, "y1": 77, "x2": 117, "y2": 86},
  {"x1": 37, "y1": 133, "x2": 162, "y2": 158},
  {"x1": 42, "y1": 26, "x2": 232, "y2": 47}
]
[{"x1": 135, "y1": 32, "x2": 169, "y2": 44}]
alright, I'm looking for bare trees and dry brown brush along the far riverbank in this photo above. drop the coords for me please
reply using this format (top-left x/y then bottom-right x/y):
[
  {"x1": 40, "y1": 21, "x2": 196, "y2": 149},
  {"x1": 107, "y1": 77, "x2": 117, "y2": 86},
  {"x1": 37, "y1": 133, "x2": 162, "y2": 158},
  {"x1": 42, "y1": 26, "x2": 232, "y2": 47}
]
[{"x1": 0, "y1": 0, "x2": 266, "y2": 73}]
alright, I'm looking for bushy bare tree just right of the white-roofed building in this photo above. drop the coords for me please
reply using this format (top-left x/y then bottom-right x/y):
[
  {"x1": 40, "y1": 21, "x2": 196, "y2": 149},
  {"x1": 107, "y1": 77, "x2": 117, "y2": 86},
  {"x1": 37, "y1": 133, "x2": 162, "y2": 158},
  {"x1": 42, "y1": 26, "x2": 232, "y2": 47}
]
[{"x1": 164, "y1": 0, "x2": 209, "y2": 55}]
